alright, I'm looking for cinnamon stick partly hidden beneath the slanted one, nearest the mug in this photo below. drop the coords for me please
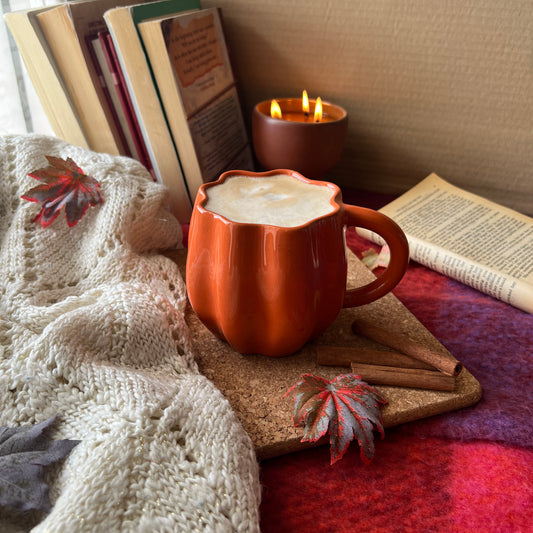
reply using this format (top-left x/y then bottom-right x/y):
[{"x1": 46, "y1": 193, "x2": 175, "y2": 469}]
[{"x1": 316, "y1": 345, "x2": 434, "y2": 370}]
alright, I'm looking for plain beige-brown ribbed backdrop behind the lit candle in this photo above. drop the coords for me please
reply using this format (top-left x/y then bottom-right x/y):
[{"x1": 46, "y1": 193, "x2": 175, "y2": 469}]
[{"x1": 202, "y1": 0, "x2": 533, "y2": 213}]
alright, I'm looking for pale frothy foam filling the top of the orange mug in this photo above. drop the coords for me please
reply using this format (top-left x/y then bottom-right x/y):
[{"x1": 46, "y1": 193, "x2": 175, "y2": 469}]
[{"x1": 205, "y1": 174, "x2": 335, "y2": 228}]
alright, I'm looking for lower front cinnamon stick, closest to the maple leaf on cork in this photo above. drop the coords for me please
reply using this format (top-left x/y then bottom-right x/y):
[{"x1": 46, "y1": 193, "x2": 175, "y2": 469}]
[{"x1": 351, "y1": 363, "x2": 455, "y2": 391}]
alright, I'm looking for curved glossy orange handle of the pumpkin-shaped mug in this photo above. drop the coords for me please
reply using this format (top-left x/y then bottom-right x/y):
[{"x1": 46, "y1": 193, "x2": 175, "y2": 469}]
[{"x1": 342, "y1": 204, "x2": 409, "y2": 307}]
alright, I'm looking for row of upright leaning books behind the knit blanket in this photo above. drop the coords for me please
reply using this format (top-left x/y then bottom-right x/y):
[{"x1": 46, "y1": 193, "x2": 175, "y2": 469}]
[{"x1": 5, "y1": 0, "x2": 253, "y2": 223}]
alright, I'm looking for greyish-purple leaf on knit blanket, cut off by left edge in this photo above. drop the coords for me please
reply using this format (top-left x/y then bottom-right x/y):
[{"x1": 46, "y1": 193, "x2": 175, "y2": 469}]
[{"x1": 0, "y1": 416, "x2": 80, "y2": 512}]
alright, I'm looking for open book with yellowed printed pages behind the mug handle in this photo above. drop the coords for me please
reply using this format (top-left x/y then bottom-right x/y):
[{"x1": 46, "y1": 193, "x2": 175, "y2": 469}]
[{"x1": 357, "y1": 174, "x2": 533, "y2": 313}]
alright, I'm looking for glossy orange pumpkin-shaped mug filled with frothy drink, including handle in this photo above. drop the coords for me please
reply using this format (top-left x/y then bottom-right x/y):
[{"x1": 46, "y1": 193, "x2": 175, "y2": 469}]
[{"x1": 186, "y1": 169, "x2": 409, "y2": 357}]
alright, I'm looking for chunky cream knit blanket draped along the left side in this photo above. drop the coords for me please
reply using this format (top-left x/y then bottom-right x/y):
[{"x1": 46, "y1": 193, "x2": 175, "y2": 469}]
[{"x1": 0, "y1": 135, "x2": 260, "y2": 533}]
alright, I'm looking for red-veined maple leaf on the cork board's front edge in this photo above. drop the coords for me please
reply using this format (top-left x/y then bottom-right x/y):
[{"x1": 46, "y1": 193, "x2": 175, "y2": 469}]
[{"x1": 285, "y1": 374, "x2": 387, "y2": 464}]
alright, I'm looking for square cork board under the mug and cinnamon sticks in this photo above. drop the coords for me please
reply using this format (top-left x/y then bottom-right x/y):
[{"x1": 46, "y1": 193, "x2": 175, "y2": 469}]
[{"x1": 167, "y1": 250, "x2": 481, "y2": 460}]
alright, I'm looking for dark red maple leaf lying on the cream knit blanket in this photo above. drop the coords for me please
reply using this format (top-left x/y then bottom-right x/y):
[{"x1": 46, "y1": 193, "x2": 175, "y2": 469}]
[{"x1": 21, "y1": 155, "x2": 103, "y2": 228}]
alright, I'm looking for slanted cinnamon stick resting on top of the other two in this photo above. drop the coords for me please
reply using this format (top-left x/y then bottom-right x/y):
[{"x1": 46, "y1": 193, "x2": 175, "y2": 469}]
[{"x1": 352, "y1": 319, "x2": 463, "y2": 376}]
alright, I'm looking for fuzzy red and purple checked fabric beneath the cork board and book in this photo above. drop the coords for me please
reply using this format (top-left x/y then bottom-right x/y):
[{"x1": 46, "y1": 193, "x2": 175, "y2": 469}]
[{"x1": 261, "y1": 192, "x2": 533, "y2": 533}]
